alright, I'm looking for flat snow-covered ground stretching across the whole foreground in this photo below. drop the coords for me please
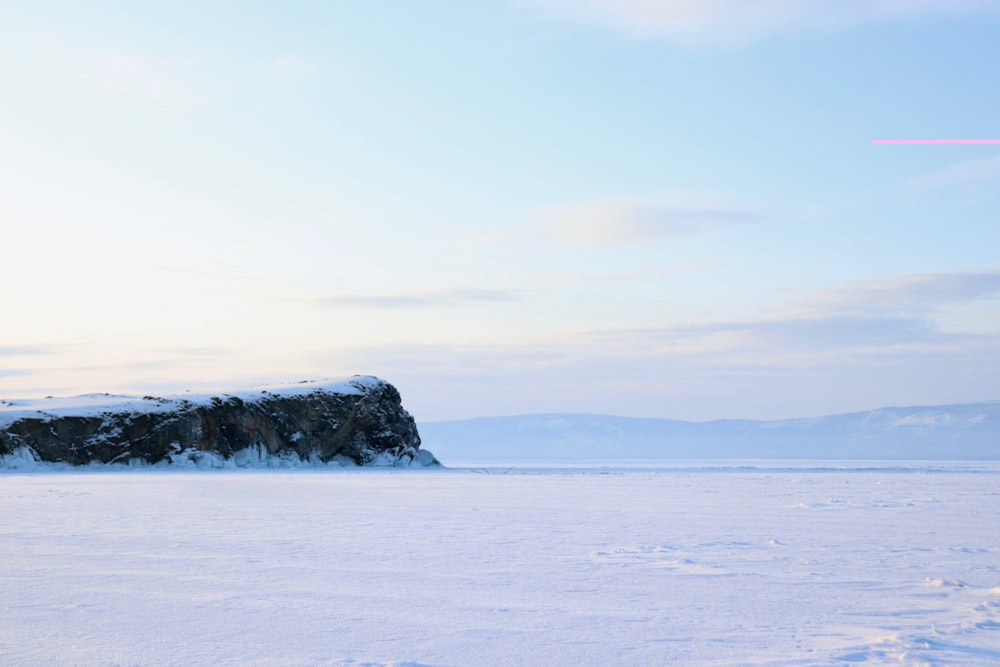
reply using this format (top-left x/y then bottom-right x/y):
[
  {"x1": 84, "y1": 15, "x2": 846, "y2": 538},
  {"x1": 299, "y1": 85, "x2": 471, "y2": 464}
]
[{"x1": 0, "y1": 462, "x2": 1000, "y2": 665}]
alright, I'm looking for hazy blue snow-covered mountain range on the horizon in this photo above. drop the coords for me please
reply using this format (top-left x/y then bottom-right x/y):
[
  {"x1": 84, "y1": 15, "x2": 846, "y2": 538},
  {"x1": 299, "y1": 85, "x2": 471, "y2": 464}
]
[{"x1": 418, "y1": 401, "x2": 1000, "y2": 465}]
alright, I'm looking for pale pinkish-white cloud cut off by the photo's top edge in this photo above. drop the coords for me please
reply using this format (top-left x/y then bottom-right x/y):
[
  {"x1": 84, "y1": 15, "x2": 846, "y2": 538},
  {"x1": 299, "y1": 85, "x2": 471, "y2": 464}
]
[{"x1": 530, "y1": 0, "x2": 998, "y2": 46}]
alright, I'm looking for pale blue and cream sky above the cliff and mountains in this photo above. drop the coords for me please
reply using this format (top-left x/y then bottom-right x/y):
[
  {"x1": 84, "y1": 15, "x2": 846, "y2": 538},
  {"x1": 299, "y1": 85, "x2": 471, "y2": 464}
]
[{"x1": 0, "y1": 0, "x2": 1000, "y2": 421}]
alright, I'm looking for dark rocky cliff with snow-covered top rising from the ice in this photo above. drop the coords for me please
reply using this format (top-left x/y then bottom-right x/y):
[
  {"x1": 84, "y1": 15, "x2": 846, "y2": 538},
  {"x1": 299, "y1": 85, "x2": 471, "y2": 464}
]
[{"x1": 0, "y1": 376, "x2": 437, "y2": 467}]
